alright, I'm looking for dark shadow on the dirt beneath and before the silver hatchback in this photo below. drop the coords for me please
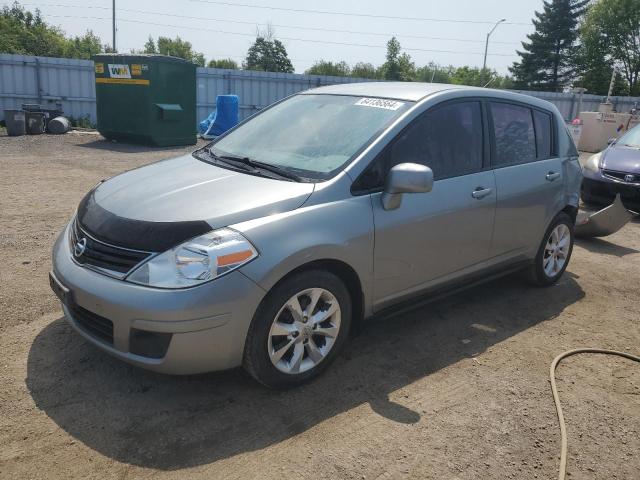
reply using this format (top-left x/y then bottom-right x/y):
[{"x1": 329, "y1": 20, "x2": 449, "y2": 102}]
[{"x1": 26, "y1": 275, "x2": 584, "y2": 470}]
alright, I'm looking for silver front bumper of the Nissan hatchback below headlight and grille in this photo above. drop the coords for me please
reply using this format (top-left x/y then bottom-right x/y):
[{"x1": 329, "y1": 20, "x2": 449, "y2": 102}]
[{"x1": 52, "y1": 221, "x2": 265, "y2": 374}]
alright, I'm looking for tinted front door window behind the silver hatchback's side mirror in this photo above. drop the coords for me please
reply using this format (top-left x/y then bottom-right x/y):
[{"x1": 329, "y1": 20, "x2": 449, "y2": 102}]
[{"x1": 389, "y1": 102, "x2": 483, "y2": 180}]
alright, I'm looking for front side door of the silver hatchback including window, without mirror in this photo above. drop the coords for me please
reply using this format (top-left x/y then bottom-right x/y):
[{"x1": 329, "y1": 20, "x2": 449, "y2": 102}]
[{"x1": 362, "y1": 100, "x2": 497, "y2": 310}]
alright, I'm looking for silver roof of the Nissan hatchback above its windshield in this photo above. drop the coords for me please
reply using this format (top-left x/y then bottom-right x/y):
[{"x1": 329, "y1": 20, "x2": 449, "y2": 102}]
[{"x1": 301, "y1": 82, "x2": 556, "y2": 111}]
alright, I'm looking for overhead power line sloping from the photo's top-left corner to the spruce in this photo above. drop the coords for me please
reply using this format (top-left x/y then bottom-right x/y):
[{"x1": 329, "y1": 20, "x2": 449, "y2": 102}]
[{"x1": 16, "y1": 3, "x2": 520, "y2": 45}]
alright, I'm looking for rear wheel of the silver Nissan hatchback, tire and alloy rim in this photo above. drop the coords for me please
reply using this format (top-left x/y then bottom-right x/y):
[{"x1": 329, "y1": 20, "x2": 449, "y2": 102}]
[{"x1": 527, "y1": 212, "x2": 574, "y2": 287}]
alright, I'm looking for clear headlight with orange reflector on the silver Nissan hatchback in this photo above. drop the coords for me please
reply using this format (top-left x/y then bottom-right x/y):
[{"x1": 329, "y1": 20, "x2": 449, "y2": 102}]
[{"x1": 126, "y1": 228, "x2": 258, "y2": 288}]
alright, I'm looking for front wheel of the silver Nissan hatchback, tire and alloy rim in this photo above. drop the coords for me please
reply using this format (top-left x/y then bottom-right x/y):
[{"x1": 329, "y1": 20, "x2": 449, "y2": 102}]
[{"x1": 243, "y1": 270, "x2": 352, "y2": 388}]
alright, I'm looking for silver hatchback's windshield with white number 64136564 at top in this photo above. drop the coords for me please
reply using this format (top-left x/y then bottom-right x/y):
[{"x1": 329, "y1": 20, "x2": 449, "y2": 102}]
[{"x1": 211, "y1": 95, "x2": 412, "y2": 180}]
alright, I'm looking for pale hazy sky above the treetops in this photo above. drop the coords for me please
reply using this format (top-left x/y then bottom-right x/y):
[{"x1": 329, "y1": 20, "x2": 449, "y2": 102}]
[{"x1": 10, "y1": 0, "x2": 542, "y2": 74}]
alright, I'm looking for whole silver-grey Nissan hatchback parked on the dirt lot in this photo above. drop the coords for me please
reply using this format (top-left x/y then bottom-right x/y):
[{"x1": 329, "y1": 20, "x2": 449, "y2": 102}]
[{"x1": 50, "y1": 83, "x2": 582, "y2": 387}]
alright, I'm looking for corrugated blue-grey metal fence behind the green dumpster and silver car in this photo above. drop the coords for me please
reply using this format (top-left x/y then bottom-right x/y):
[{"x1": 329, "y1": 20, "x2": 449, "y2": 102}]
[{"x1": 0, "y1": 54, "x2": 640, "y2": 123}]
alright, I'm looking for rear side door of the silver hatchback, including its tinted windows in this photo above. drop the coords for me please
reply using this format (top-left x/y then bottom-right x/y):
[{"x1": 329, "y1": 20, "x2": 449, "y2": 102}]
[{"x1": 489, "y1": 100, "x2": 563, "y2": 260}]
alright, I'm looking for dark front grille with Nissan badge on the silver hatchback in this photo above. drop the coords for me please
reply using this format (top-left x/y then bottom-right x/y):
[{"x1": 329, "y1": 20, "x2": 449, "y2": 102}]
[{"x1": 70, "y1": 220, "x2": 151, "y2": 277}]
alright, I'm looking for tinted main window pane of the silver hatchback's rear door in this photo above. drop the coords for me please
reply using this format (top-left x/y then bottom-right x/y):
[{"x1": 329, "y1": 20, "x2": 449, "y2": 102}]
[{"x1": 491, "y1": 103, "x2": 536, "y2": 167}]
